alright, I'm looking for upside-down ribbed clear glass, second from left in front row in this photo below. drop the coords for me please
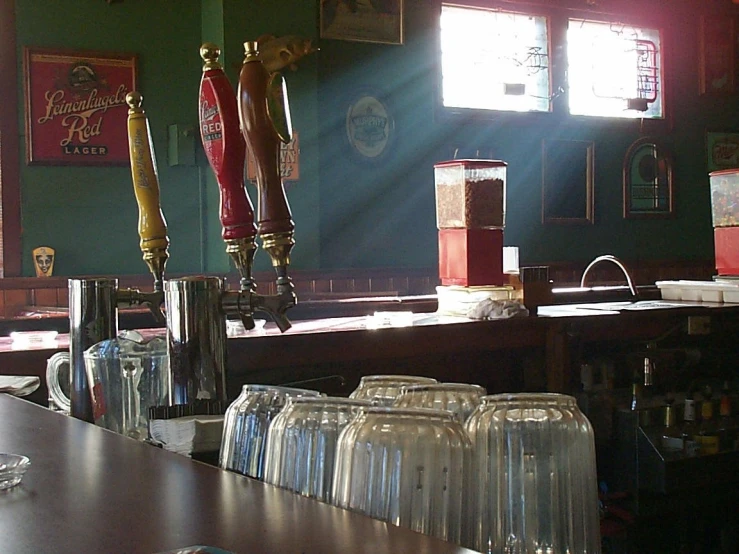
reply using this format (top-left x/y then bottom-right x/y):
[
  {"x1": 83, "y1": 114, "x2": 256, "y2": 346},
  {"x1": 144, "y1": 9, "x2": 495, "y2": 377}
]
[{"x1": 264, "y1": 397, "x2": 370, "y2": 502}]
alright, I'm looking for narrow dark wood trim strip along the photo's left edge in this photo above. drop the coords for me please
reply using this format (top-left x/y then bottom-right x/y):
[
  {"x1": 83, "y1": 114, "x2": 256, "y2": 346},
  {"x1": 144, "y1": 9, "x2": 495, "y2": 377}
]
[{"x1": 0, "y1": 0, "x2": 21, "y2": 277}]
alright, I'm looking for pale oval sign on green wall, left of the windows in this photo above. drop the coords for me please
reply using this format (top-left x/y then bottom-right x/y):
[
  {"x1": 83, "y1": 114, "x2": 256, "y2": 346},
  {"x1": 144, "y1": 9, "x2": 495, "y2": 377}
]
[{"x1": 346, "y1": 94, "x2": 395, "y2": 160}]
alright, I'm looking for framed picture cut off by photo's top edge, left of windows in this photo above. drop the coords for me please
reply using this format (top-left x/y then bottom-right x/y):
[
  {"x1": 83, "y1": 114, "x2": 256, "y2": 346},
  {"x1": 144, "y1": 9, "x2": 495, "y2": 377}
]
[{"x1": 321, "y1": 0, "x2": 403, "y2": 44}]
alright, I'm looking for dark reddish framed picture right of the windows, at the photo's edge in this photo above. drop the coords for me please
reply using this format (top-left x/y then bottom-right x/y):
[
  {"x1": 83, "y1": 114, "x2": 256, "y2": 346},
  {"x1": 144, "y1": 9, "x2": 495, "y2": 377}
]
[{"x1": 699, "y1": 16, "x2": 736, "y2": 94}]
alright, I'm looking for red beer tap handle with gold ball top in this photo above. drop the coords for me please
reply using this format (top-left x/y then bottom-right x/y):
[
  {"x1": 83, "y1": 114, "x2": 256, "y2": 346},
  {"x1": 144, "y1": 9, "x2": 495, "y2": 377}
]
[{"x1": 199, "y1": 42, "x2": 257, "y2": 290}]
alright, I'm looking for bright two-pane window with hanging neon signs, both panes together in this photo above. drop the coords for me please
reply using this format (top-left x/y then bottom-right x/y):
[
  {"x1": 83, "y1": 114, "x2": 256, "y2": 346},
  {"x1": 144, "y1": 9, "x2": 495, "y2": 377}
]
[{"x1": 440, "y1": 4, "x2": 664, "y2": 119}]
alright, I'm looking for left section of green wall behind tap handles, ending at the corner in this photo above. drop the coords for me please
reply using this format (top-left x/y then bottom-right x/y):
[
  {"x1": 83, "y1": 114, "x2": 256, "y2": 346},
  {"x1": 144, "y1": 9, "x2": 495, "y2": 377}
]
[{"x1": 16, "y1": 0, "x2": 319, "y2": 275}]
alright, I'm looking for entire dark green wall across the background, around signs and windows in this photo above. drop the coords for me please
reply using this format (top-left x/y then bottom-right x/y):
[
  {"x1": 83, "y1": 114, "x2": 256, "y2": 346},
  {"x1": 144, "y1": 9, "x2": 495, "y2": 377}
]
[{"x1": 11, "y1": 0, "x2": 739, "y2": 275}]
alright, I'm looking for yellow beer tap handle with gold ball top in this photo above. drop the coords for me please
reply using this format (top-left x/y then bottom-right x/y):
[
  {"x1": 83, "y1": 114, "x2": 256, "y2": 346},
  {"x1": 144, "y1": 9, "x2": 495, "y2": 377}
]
[{"x1": 126, "y1": 91, "x2": 169, "y2": 290}]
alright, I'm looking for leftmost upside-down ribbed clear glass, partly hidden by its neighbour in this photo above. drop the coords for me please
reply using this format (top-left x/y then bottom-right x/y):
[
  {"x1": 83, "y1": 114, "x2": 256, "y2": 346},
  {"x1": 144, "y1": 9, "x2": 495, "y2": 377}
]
[{"x1": 218, "y1": 385, "x2": 321, "y2": 479}]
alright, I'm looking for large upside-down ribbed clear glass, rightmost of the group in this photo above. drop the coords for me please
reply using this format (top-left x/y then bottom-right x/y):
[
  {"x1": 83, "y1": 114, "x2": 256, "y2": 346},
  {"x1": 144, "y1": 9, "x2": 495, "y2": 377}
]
[{"x1": 465, "y1": 393, "x2": 600, "y2": 554}]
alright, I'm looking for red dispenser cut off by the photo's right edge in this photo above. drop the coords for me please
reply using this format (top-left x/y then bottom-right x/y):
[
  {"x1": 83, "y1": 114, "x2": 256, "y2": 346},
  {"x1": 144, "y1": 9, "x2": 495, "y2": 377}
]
[{"x1": 709, "y1": 169, "x2": 739, "y2": 275}]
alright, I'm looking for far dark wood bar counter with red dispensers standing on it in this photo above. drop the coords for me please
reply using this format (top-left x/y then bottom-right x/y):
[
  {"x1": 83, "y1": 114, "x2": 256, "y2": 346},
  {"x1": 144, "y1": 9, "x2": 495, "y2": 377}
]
[{"x1": 0, "y1": 300, "x2": 739, "y2": 403}]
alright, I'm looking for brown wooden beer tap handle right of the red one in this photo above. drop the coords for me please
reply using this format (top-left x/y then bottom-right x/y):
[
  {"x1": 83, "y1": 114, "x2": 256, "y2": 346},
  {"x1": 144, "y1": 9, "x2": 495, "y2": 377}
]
[{"x1": 238, "y1": 42, "x2": 295, "y2": 303}]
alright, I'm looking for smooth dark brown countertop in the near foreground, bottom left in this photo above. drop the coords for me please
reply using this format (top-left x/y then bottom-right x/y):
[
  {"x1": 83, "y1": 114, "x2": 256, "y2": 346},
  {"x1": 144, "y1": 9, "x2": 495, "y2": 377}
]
[{"x1": 0, "y1": 394, "x2": 471, "y2": 554}]
